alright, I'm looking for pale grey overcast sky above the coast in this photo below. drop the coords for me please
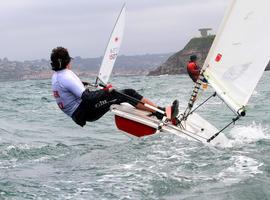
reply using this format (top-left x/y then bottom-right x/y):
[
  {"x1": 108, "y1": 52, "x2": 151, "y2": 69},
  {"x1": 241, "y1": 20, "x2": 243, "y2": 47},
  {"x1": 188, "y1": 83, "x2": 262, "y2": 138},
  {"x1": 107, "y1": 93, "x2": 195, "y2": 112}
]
[{"x1": 0, "y1": 0, "x2": 230, "y2": 61}]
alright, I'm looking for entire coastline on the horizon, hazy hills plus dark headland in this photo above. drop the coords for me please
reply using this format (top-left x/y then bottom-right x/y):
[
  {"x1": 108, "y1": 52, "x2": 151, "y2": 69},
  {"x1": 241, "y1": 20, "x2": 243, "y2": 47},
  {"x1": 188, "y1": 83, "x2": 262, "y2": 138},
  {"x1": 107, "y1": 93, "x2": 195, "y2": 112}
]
[{"x1": 0, "y1": 35, "x2": 270, "y2": 81}]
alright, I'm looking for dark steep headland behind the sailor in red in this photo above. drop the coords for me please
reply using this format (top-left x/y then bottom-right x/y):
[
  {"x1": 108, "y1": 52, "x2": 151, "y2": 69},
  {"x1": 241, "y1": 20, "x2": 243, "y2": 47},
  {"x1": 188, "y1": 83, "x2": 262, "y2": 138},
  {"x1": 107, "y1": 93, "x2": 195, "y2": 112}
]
[{"x1": 148, "y1": 35, "x2": 270, "y2": 76}]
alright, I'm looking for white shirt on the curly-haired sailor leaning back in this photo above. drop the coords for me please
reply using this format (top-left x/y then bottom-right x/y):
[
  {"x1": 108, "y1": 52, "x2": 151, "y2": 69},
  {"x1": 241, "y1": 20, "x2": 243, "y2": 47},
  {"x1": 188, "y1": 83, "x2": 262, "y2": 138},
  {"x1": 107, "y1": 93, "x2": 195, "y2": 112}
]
[{"x1": 52, "y1": 69, "x2": 85, "y2": 117}]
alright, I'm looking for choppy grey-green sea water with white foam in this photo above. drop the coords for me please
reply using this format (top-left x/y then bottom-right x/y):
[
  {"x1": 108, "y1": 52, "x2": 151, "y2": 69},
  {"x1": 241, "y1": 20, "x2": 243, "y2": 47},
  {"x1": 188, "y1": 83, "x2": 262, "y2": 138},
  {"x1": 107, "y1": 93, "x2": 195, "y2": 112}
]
[{"x1": 0, "y1": 72, "x2": 270, "y2": 200}]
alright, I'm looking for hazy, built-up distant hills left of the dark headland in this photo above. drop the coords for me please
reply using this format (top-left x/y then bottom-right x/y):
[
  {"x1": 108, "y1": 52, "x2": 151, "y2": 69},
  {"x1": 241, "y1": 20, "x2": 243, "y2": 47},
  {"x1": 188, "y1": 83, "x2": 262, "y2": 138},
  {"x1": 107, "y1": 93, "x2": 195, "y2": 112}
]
[{"x1": 0, "y1": 54, "x2": 171, "y2": 81}]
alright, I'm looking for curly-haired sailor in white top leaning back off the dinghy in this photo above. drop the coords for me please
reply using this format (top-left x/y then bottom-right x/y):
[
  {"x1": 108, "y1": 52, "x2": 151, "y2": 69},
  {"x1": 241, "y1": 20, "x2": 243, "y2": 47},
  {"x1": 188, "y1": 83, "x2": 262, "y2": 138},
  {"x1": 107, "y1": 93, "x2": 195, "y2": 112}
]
[{"x1": 51, "y1": 47, "x2": 179, "y2": 126}]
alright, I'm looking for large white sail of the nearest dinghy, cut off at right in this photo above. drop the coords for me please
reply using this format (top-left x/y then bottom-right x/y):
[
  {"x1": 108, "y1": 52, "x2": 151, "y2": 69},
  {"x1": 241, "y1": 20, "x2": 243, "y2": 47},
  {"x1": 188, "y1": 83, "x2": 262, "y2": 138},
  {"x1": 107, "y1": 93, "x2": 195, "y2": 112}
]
[{"x1": 203, "y1": 0, "x2": 270, "y2": 114}]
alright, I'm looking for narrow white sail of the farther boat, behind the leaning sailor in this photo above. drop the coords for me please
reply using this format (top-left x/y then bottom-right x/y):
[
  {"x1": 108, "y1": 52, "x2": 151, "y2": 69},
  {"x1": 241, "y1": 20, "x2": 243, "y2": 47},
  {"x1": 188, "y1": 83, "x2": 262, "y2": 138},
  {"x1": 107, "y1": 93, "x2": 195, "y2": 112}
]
[{"x1": 97, "y1": 4, "x2": 126, "y2": 85}]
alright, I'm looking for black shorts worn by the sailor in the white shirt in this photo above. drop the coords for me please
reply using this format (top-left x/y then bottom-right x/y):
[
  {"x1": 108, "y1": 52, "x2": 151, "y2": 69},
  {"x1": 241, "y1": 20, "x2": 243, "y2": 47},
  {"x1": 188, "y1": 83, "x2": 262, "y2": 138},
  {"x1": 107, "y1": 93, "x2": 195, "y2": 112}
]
[{"x1": 72, "y1": 89, "x2": 143, "y2": 126}]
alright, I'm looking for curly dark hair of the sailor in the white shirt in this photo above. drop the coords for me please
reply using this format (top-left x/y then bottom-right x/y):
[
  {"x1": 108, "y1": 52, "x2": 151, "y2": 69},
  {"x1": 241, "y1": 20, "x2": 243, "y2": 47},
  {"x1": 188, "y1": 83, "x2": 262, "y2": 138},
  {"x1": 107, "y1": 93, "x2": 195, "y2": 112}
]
[{"x1": 51, "y1": 47, "x2": 71, "y2": 71}]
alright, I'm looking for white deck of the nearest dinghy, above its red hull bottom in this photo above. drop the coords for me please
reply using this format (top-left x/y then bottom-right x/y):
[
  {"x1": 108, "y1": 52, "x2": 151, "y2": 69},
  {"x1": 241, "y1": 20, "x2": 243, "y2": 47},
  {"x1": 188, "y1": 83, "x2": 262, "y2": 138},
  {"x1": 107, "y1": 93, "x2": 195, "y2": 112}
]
[{"x1": 111, "y1": 104, "x2": 229, "y2": 146}]
